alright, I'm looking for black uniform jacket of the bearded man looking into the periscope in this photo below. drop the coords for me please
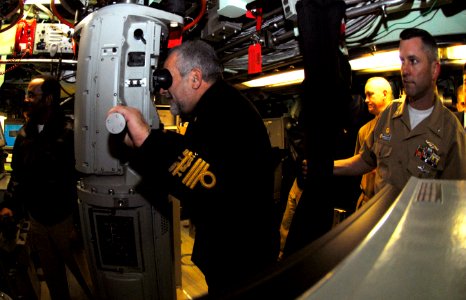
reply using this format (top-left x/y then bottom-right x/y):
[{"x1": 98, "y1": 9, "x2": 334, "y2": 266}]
[{"x1": 132, "y1": 81, "x2": 279, "y2": 288}]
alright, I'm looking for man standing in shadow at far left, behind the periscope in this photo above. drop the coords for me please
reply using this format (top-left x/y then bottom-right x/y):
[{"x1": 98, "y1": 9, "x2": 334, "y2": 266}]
[{"x1": 0, "y1": 75, "x2": 91, "y2": 300}]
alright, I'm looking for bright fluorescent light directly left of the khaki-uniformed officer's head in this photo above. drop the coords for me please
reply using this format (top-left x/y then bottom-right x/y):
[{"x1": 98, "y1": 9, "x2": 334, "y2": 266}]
[{"x1": 350, "y1": 50, "x2": 401, "y2": 72}]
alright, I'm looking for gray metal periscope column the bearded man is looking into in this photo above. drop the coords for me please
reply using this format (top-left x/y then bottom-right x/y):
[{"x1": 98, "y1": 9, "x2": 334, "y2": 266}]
[{"x1": 74, "y1": 3, "x2": 183, "y2": 300}]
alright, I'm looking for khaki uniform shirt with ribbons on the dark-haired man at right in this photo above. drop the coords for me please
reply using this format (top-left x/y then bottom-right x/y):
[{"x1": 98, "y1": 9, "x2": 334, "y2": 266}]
[{"x1": 361, "y1": 97, "x2": 466, "y2": 193}]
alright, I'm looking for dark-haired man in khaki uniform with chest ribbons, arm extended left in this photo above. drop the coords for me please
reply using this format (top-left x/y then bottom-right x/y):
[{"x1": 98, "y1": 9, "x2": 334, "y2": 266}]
[{"x1": 333, "y1": 28, "x2": 466, "y2": 193}]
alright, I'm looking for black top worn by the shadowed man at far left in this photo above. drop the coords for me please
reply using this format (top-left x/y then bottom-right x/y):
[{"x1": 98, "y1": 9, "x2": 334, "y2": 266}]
[{"x1": 2, "y1": 111, "x2": 77, "y2": 225}]
